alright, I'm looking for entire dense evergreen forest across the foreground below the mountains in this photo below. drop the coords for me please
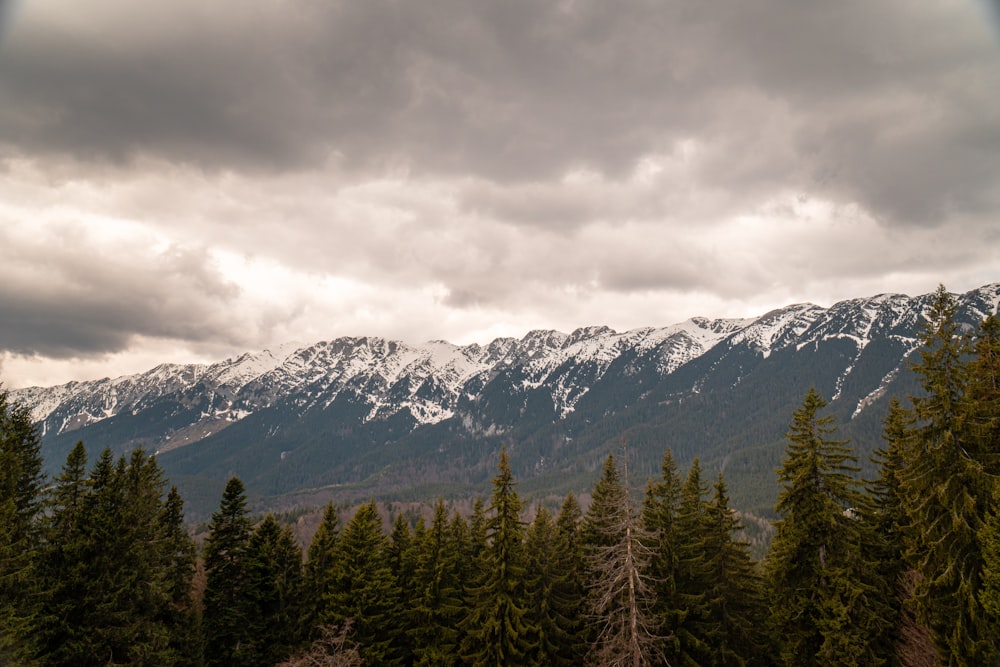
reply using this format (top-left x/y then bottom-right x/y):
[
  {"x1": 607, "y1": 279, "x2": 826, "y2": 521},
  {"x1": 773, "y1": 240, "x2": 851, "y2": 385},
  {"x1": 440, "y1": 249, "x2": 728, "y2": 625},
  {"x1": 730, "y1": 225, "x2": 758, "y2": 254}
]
[{"x1": 0, "y1": 288, "x2": 1000, "y2": 667}]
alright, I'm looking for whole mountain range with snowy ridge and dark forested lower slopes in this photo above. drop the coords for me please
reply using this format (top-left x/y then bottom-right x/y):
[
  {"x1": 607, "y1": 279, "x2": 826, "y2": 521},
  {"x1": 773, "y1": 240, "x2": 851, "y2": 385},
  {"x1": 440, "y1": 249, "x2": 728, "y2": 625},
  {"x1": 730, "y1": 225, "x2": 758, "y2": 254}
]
[{"x1": 11, "y1": 283, "x2": 1000, "y2": 520}]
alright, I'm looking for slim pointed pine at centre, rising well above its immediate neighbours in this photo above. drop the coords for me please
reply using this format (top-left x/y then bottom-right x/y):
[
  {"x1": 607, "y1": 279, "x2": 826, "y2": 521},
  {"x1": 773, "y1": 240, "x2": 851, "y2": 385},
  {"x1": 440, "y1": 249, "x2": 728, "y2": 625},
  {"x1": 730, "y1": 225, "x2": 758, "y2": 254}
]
[{"x1": 462, "y1": 449, "x2": 532, "y2": 667}]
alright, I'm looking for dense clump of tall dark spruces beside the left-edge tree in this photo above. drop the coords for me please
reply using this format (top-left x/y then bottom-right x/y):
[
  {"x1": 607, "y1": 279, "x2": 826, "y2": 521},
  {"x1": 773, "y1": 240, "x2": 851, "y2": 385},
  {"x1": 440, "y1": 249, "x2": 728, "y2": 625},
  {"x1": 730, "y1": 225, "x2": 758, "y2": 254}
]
[{"x1": 38, "y1": 443, "x2": 197, "y2": 666}]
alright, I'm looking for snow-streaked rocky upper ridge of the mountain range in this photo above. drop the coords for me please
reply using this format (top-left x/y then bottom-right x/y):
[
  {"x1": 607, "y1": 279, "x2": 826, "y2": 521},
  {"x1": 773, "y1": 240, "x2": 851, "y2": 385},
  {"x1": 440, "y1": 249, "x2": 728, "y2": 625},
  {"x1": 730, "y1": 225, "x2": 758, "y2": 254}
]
[{"x1": 11, "y1": 283, "x2": 1000, "y2": 452}]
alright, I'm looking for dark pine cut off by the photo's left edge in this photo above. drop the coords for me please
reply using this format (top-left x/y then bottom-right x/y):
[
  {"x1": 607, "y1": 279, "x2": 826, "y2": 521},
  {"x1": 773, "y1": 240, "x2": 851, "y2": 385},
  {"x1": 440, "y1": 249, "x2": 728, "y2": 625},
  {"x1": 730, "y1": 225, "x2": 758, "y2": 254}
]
[{"x1": 0, "y1": 386, "x2": 44, "y2": 664}]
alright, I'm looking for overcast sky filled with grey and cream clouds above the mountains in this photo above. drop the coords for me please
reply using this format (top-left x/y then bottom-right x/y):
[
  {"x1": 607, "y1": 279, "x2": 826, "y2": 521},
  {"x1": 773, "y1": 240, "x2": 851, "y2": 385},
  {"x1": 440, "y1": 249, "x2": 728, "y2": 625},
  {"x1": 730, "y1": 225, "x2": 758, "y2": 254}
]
[{"x1": 0, "y1": 0, "x2": 1000, "y2": 388}]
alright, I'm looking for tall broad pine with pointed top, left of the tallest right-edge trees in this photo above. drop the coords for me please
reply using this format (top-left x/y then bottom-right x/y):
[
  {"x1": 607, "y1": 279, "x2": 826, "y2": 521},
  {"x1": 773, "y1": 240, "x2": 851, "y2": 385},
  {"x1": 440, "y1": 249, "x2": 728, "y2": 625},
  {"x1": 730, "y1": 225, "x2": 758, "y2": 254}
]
[{"x1": 768, "y1": 389, "x2": 884, "y2": 665}]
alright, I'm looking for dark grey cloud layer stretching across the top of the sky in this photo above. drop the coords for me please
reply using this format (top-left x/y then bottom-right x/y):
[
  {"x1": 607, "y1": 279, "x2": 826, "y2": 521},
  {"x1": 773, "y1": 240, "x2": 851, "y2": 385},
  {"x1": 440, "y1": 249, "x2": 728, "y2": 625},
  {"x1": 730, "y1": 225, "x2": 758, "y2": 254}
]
[{"x1": 0, "y1": 0, "x2": 1000, "y2": 223}]
